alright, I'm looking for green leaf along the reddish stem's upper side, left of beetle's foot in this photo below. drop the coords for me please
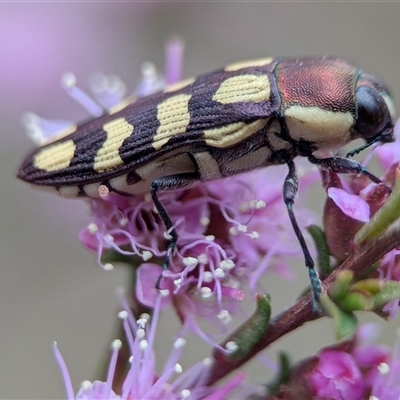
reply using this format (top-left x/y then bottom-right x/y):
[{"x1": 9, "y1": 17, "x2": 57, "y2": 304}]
[{"x1": 227, "y1": 295, "x2": 271, "y2": 360}]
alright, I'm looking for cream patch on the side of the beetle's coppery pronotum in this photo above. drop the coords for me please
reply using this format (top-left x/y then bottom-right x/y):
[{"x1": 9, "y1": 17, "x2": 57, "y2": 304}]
[{"x1": 285, "y1": 106, "x2": 354, "y2": 149}]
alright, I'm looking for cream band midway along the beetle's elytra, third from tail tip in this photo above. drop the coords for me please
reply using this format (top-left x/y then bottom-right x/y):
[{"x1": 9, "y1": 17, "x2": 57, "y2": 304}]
[{"x1": 153, "y1": 94, "x2": 192, "y2": 150}]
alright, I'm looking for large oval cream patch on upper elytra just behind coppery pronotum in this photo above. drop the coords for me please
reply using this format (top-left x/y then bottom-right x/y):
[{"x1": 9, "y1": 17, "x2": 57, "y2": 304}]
[{"x1": 213, "y1": 74, "x2": 271, "y2": 104}]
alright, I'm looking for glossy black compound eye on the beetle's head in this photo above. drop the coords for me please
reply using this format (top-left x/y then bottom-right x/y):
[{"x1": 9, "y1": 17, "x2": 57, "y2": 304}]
[{"x1": 354, "y1": 86, "x2": 388, "y2": 141}]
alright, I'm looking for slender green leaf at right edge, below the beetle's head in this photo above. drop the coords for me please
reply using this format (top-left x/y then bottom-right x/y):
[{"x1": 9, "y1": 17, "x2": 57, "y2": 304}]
[{"x1": 354, "y1": 176, "x2": 400, "y2": 244}]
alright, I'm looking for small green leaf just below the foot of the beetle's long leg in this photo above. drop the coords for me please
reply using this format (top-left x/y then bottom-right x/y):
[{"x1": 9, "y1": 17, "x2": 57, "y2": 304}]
[{"x1": 320, "y1": 294, "x2": 358, "y2": 340}]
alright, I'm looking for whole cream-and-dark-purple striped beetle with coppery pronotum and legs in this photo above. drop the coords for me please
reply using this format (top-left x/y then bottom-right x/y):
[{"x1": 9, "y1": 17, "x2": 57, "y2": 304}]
[{"x1": 18, "y1": 58, "x2": 394, "y2": 301}]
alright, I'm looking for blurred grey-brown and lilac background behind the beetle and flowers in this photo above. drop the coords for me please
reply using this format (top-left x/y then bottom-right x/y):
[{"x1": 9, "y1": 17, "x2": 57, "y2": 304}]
[{"x1": 0, "y1": 1, "x2": 400, "y2": 399}]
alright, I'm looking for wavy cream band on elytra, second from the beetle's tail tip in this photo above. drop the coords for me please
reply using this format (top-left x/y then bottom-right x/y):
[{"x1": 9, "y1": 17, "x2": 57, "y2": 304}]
[{"x1": 93, "y1": 118, "x2": 133, "y2": 172}]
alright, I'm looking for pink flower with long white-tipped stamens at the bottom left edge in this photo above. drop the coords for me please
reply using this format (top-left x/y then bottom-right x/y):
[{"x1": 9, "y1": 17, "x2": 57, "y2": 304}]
[{"x1": 54, "y1": 296, "x2": 245, "y2": 400}]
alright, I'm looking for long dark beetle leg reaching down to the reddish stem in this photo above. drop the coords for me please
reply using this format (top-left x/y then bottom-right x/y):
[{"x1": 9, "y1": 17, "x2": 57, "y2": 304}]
[{"x1": 283, "y1": 161, "x2": 322, "y2": 311}]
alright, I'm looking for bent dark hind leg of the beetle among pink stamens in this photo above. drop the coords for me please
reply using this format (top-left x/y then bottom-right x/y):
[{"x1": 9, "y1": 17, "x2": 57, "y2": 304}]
[{"x1": 150, "y1": 172, "x2": 200, "y2": 290}]
